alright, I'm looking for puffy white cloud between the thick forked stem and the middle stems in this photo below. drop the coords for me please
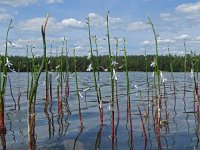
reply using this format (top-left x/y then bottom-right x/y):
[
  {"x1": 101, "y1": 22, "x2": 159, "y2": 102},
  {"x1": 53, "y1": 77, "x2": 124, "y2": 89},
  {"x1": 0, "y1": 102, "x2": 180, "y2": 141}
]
[{"x1": 61, "y1": 18, "x2": 86, "y2": 28}]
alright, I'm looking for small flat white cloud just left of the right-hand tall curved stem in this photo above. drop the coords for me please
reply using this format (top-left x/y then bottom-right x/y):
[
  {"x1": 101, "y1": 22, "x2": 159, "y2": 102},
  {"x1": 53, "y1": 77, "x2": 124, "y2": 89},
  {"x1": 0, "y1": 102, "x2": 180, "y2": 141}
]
[{"x1": 127, "y1": 22, "x2": 150, "y2": 31}]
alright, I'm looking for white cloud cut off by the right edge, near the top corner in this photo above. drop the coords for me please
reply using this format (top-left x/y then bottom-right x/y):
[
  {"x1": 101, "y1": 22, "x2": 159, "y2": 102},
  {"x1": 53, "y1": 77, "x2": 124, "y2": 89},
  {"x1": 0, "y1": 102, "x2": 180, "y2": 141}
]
[{"x1": 176, "y1": 2, "x2": 200, "y2": 13}]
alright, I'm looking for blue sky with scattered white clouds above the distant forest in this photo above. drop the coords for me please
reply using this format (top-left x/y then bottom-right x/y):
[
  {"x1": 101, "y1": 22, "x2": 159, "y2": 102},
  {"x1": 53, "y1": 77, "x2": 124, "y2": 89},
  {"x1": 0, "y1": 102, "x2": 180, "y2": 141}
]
[{"x1": 0, "y1": 0, "x2": 200, "y2": 56}]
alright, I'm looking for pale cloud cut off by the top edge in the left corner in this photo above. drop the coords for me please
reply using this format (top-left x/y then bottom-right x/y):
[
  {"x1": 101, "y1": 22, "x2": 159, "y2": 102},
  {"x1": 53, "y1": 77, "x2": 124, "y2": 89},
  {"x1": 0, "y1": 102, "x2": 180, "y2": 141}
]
[{"x1": 0, "y1": 0, "x2": 37, "y2": 7}]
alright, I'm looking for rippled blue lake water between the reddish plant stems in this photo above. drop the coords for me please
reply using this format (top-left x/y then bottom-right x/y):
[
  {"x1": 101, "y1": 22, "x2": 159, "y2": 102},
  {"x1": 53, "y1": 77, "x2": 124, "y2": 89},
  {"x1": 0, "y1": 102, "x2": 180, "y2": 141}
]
[{"x1": 1, "y1": 72, "x2": 200, "y2": 150}]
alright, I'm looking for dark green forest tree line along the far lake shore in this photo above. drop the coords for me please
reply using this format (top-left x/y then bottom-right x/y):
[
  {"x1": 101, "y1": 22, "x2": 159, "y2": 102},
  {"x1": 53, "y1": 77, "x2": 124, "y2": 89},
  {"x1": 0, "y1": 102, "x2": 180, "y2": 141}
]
[{"x1": 1, "y1": 55, "x2": 197, "y2": 72}]
